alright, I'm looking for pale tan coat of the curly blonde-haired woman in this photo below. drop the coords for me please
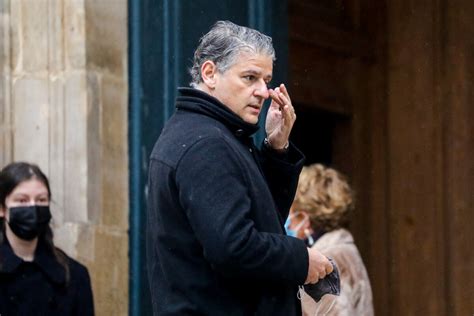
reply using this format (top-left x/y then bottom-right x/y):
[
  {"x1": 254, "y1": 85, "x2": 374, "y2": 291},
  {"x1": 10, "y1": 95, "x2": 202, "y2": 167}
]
[{"x1": 301, "y1": 229, "x2": 374, "y2": 316}]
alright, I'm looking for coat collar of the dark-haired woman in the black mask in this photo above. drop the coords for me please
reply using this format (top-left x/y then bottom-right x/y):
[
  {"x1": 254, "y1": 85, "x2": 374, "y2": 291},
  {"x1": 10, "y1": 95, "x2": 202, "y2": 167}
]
[{"x1": 0, "y1": 236, "x2": 66, "y2": 284}]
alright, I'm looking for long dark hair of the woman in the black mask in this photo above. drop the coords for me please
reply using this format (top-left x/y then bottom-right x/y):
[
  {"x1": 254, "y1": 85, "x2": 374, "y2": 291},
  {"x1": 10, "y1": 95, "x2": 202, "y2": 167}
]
[{"x1": 0, "y1": 162, "x2": 69, "y2": 281}]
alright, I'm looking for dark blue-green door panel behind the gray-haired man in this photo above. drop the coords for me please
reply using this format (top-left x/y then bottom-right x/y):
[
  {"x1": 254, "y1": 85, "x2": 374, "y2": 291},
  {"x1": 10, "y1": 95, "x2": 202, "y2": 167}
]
[{"x1": 129, "y1": 0, "x2": 288, "y2": 316}]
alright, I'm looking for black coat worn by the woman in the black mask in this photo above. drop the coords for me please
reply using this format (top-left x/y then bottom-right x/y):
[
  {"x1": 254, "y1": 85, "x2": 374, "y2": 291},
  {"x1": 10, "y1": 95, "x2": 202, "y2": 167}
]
[{"x1": 0, "y1": 238, "x2": 94, "y2": 316}]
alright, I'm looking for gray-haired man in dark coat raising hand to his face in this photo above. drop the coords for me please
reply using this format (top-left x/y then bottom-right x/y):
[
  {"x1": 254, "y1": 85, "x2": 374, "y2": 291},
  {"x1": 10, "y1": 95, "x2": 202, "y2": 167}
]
[{"x1": 147, "y1": 21, "x2": 333, "y2": 316}]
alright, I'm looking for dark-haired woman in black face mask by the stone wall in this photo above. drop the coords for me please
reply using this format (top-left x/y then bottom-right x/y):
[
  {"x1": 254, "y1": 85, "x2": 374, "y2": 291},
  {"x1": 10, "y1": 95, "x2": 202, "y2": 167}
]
[{"x1": 0, "y1": 162, "x2": 94, "y2": 315}]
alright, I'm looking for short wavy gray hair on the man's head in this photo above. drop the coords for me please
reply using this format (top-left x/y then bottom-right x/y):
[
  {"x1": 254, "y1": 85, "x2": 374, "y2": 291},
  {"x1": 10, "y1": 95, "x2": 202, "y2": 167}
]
[{"x1": 190, "y1": 21, "x2": 276, "y2": 87}]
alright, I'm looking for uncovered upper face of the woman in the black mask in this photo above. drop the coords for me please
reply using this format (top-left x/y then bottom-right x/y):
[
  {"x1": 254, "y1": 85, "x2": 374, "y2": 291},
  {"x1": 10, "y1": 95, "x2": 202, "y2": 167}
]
[{"x1": 0, "y1": 178, "x2": 49, "y2": 220}]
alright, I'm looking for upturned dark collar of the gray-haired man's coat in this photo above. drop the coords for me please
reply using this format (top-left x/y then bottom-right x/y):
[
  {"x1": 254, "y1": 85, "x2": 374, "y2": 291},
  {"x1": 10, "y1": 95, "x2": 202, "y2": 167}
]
[{"x1": 176, "y1": 87, "x2": 259, "y2": 137}]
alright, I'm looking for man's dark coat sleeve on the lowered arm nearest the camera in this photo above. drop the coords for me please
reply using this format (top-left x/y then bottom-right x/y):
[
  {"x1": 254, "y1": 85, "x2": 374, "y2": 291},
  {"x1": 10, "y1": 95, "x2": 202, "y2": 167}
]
[{"x1": 176, "y1": 138, "x2": 308, "y2": 284}]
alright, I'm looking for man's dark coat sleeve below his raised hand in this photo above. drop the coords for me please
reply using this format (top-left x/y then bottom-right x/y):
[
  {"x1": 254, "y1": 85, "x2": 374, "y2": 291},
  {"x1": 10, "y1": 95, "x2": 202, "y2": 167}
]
[{"x1": 260, "y1": 142, "x2": 305, "y2": 221}]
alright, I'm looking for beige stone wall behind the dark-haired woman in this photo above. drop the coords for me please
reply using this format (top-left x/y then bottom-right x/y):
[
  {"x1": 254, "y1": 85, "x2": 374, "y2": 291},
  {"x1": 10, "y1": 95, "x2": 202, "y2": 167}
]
[{"x1": 0, "y1": 0, "x2": 128, "y2": 315}]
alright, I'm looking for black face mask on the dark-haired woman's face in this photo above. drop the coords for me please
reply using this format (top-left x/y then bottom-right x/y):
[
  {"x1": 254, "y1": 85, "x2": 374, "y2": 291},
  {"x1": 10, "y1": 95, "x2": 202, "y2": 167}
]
[{"x1": 8, "y1": 205, "x2": 51, "y2": 240}]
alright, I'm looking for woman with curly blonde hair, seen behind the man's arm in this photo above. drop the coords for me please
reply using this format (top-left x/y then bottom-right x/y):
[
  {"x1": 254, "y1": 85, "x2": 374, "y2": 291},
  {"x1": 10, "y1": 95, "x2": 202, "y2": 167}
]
[{"x1": 287, "y1": 164, "x2": 374, "y2": 316}]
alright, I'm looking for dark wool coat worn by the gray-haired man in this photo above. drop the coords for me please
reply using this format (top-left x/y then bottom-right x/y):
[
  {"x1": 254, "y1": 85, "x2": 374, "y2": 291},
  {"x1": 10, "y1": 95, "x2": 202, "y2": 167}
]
[{"x1": 147, "y1": 88, "x2": 308, "y2": 316}]
